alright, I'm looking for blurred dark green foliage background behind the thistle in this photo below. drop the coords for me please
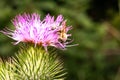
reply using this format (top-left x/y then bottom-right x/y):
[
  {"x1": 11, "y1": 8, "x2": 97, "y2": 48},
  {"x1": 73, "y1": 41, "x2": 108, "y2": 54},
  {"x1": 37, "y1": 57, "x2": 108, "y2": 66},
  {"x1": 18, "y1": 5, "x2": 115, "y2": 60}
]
[{"x1": 0, "y1": 0, "x2": 120, "y2": 80}]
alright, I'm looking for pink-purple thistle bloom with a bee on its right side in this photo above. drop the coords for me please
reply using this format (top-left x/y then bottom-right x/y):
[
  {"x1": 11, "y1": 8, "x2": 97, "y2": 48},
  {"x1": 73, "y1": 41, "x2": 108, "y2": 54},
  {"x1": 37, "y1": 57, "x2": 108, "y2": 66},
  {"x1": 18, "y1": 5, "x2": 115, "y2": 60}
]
[{"x1": 2, "y1": 13, "x2": 71, "y2": 50}]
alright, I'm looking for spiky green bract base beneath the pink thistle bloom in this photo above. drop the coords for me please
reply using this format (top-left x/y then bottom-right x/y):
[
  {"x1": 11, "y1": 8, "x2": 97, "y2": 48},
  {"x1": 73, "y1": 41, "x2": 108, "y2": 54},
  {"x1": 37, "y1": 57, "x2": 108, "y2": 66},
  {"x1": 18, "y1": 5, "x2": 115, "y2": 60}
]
[{"x1": 0, "y1": 46, "x2": 66, "y2": 80}]
